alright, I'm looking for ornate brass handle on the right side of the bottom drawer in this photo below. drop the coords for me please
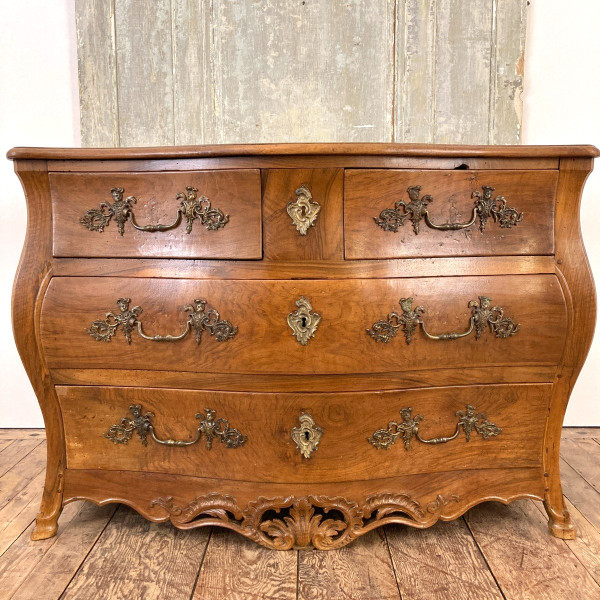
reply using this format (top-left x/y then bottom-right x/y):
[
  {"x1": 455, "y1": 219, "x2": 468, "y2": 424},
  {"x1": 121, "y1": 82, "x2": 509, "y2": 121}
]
[{"x1": 367, "y1": 404, "x2": 502, "y2": 450}]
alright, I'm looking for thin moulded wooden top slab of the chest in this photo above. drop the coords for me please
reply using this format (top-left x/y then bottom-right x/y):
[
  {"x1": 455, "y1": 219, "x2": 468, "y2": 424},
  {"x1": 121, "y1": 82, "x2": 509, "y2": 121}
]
[{"x1": 7, "y1": 143, "x2": 600, "y2": 160}]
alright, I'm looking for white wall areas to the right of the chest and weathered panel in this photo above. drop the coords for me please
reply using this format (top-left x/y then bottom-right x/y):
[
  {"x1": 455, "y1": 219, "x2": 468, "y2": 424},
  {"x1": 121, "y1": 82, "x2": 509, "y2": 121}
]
[{"x1": 523, "y1": 0, "x2": 600, "y2": 425}]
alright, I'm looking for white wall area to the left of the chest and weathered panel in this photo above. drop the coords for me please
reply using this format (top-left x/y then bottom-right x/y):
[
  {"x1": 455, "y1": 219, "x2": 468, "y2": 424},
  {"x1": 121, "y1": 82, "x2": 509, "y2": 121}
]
[{"x1": 0, "y1": 0, "x2": 80, "y2": 427}]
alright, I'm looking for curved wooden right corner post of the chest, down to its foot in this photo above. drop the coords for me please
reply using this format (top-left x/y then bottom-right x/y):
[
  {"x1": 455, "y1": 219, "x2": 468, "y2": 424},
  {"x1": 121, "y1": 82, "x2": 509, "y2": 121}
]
[{"x1": 544, "y1": 158, "x2": 596, "y2": 539}]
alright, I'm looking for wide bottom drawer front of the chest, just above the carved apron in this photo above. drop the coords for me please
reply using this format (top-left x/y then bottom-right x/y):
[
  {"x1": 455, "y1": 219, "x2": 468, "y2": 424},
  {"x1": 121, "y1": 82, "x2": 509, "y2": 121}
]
[{"x1": 57, "y1": 384, "x2": 551, "y2": 483}]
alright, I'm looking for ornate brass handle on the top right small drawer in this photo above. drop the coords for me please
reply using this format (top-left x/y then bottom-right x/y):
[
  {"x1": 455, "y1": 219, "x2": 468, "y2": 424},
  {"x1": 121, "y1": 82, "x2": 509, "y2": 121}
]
[{"x1": 373, "y1": 185, "x2": 523, "y2": 235}]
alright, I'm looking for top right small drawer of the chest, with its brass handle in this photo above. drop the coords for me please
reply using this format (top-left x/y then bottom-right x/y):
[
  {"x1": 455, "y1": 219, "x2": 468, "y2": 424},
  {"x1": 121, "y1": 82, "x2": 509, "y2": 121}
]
[{"x1": 344, "y1": 169, "x2": 558, "y2": 260}]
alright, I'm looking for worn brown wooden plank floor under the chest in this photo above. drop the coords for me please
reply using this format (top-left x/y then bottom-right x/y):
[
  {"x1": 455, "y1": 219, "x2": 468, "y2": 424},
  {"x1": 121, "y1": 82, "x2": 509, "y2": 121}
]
[{"x1": 0, "y1": 429, "x2": 600, "y2": 600}]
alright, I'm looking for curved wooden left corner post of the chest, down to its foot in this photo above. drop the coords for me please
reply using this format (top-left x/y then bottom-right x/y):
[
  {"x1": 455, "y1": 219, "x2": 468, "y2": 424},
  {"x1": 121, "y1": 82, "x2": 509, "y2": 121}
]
[{"x1": 12, "y1": 160, "x2": 65, "y2": 540}]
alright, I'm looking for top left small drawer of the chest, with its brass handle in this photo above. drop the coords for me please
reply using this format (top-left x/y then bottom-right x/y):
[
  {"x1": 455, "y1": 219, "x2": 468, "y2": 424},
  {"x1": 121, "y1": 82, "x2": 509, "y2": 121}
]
[{"x1": 50, "y1": 169, "x2": 262, "y2": 259}]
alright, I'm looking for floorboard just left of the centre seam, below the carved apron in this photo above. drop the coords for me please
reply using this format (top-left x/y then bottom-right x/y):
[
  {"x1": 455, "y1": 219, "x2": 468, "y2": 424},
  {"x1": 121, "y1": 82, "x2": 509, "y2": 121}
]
[{"x1": 191, "y1": 528, "x2": 298, "y2": 600}]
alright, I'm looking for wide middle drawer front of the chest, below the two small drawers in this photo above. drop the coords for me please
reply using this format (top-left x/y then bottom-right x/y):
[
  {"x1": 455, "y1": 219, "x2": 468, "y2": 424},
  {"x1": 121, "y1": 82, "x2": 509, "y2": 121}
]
[{"x1": 41, "y1": 275, "x2": 567, "y2": 381}]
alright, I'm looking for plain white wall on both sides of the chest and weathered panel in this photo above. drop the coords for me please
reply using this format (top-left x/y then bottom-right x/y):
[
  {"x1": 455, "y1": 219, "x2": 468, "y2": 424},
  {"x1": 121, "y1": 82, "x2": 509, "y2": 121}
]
[{"x1": 0, "y1": 0, "x2": 600, "y2": 427}]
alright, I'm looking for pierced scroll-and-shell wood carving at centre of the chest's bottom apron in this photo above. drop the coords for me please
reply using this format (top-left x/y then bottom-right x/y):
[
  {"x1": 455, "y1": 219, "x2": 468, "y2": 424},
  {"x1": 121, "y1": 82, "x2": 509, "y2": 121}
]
[{"x1": 150, "y1": 493, "x2": 460, "y2": 550}]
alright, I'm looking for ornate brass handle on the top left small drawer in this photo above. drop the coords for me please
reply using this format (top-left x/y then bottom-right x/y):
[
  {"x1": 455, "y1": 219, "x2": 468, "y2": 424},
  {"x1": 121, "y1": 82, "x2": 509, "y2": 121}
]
[{"x1": 79, "y1": 186, "x2": 229, "y2": 235}]
